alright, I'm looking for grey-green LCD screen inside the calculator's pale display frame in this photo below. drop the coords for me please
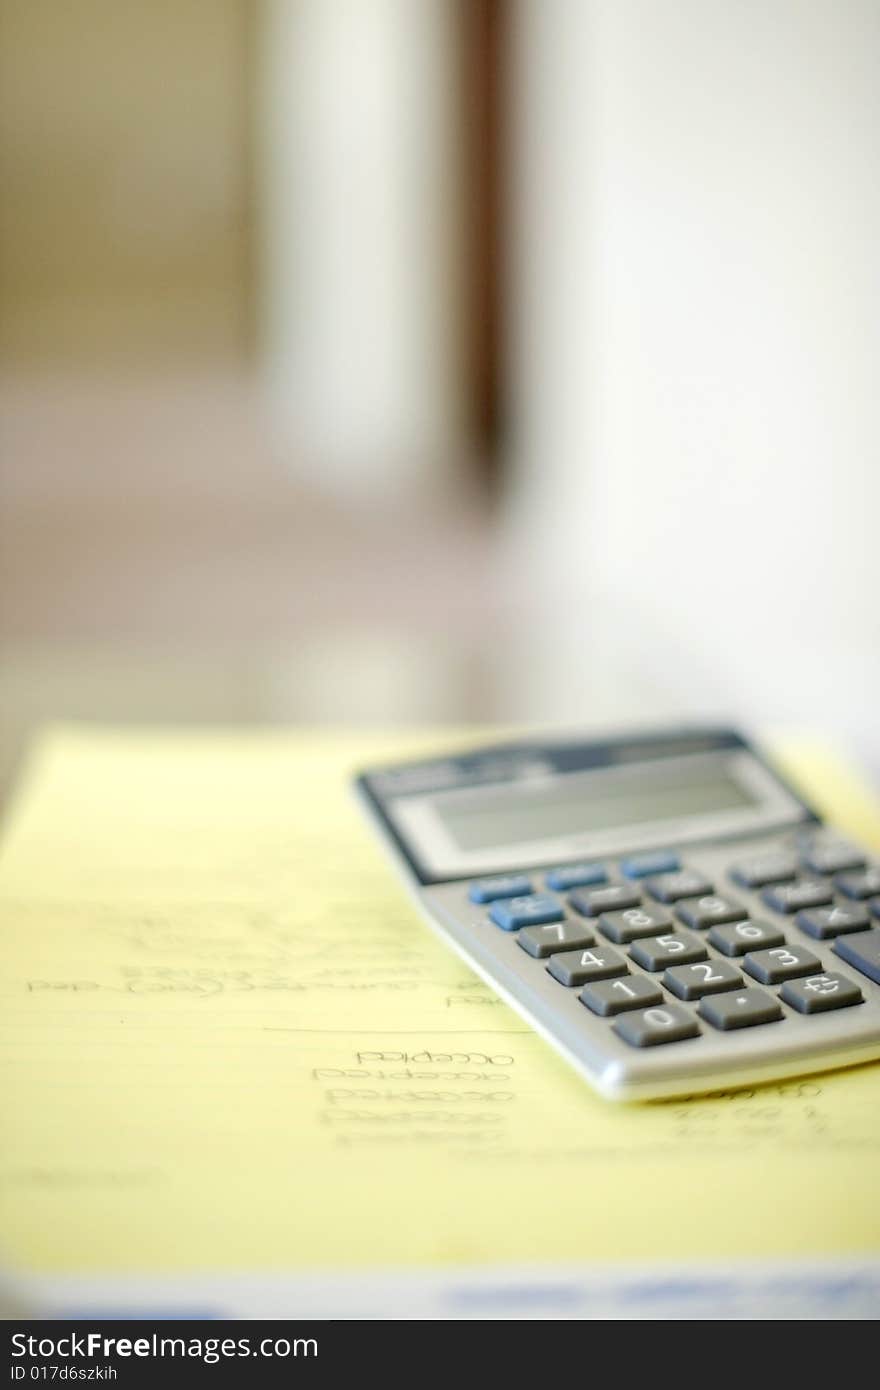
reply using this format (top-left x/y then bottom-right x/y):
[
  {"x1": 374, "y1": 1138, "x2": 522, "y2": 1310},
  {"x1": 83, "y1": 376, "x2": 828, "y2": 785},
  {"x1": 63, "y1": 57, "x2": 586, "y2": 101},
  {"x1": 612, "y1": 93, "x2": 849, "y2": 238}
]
[{"x1": 437, "y1": 760, "x2": 755, "y2": 851}]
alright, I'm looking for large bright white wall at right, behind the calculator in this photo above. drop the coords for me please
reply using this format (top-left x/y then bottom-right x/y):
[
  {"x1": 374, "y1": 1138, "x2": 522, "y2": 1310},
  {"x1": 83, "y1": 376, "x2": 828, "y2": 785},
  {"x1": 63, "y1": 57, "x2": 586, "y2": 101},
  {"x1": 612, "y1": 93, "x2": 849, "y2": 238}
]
[{"x1": 509, "y1": 0, "x2": 880, "y2": 766}]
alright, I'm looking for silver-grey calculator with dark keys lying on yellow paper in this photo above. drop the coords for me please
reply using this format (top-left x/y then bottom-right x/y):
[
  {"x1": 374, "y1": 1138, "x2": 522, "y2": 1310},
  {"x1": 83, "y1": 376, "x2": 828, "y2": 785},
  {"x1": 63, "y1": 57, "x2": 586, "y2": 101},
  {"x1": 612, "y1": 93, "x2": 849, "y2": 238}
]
[{"x1": 357, "y1": 728, "x2": 880, "y2": 1099}]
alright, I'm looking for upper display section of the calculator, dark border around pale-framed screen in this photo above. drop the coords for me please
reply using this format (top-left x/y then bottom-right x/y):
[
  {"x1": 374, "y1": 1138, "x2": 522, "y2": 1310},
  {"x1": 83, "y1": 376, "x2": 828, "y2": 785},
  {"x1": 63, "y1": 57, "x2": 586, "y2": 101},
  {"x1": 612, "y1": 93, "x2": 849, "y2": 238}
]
[{"x1": 366, "y1": 730, "x2": 815, "y2": 883}]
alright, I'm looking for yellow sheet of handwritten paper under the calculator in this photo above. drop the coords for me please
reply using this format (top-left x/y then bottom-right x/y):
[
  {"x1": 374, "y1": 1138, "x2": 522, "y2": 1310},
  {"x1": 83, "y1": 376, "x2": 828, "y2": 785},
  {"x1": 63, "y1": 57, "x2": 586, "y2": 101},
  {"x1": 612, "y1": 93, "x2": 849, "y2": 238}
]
[{"x1": 0, "y1": 730, "x2": 880, "y2": 1275}]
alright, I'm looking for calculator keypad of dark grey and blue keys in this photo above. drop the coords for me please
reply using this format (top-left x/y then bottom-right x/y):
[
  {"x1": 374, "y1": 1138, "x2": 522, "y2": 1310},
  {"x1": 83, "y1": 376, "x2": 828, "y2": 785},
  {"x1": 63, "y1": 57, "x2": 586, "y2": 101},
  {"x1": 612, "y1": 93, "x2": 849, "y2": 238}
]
[{"x1": 470, "y1": 841, "x2": 880, "y2": 1078}]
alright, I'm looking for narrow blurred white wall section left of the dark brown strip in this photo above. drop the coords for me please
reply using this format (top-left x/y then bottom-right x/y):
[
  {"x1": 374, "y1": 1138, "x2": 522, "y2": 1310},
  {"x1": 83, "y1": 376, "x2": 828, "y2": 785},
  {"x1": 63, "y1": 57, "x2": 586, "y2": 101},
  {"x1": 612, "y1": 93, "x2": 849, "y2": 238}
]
[{"x1": 259, "y1": 0, "x2": 464, "y2": 503}]
